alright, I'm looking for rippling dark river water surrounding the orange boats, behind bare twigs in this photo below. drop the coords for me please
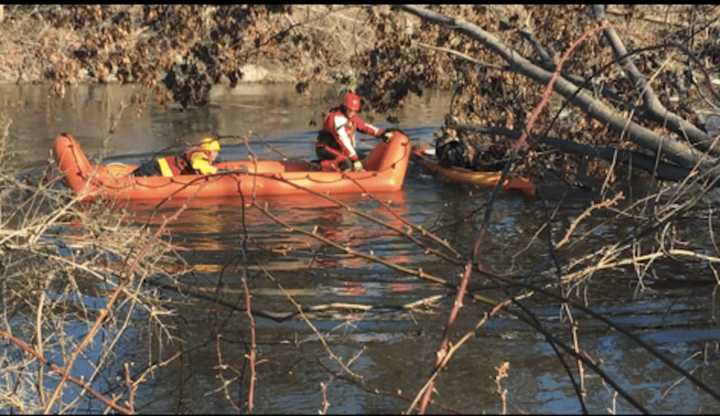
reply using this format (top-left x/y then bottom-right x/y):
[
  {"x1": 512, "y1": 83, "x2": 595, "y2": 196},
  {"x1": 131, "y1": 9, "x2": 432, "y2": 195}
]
[{"x1": 0, "y1": 85, "x2": 720, "y2": 413}]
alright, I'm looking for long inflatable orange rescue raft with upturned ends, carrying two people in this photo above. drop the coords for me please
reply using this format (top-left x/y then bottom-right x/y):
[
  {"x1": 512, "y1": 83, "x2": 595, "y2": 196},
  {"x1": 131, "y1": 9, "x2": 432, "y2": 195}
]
[{"x1": 53, "y1": 131, "x2": 411, "y2": 200}]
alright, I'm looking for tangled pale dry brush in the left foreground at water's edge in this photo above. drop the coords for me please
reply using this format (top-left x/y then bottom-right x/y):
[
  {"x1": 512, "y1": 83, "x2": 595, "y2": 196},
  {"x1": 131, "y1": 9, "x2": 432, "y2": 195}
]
[{"x1": 0, "y1": 114, "x2": 188, "y2": 414}]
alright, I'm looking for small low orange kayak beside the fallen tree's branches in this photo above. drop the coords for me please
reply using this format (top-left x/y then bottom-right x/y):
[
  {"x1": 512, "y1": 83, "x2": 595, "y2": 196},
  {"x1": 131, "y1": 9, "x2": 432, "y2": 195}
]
[{"x1": 413, "y1": 145, "x2": 535, "y2": 196}]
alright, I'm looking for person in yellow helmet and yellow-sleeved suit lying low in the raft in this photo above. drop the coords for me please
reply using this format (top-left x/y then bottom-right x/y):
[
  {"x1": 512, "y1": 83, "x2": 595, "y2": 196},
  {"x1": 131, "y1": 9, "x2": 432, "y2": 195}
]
[{"x1": 132, "y1": 137, "x2": 225, "y2": 177}]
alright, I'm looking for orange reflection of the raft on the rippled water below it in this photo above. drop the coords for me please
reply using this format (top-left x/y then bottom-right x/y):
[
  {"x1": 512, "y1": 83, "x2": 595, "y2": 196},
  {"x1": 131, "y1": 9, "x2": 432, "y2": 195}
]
[{"x1": 117, "y1": 191, "x2": 411, "y2": 272}]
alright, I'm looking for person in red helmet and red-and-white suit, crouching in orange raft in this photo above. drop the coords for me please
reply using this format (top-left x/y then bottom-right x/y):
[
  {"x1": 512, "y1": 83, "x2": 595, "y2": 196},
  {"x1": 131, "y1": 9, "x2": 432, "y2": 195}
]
[{"x1": 315, "y1": 92, "x2": 392, "y2": 172}]
